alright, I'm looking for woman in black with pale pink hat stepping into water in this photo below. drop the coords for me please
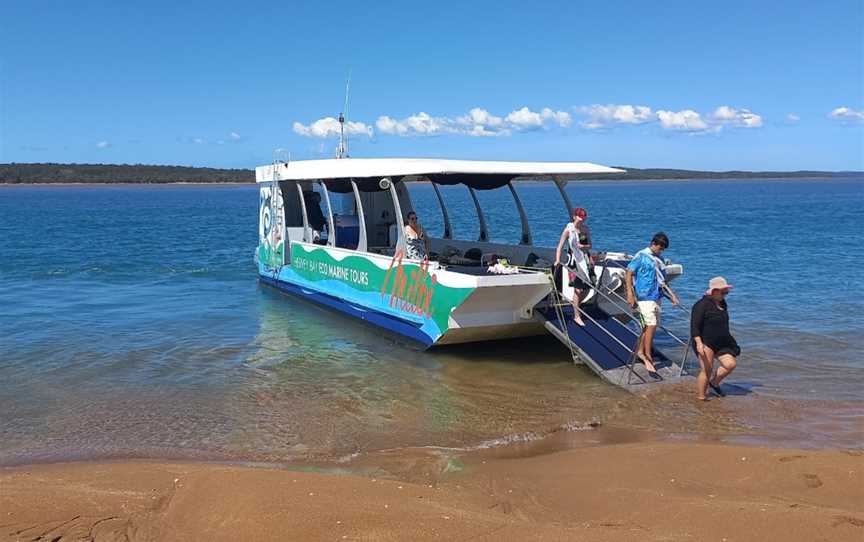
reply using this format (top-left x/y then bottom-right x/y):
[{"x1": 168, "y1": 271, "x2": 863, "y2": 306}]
[{"x1": 690, "y1": 277, "x2": 741, "y2": 401}]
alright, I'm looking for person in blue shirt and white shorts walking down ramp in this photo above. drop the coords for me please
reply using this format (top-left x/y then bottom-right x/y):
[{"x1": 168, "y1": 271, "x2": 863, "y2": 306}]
[{"x1": 626, "y1": 232, "x2": 678, "y2": 376}]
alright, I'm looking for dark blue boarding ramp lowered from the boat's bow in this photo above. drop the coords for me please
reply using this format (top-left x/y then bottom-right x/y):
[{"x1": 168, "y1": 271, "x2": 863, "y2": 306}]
[{"x1": 536, "y1": 268, "x2": 690, "y2": 393}]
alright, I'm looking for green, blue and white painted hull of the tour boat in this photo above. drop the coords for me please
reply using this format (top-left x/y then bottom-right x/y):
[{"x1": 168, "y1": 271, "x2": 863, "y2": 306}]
[{"x1": 259, "y1": 242, "x2": 550, "y2": 347}]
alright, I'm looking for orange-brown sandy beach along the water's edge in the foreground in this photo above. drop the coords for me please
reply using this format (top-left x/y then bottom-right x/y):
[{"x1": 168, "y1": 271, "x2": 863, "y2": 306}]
[{"x1": 0, "y1": 442, "x2": 864, "y2": 542}]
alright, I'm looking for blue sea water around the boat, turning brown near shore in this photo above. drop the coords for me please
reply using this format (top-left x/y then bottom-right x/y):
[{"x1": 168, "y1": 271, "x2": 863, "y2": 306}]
[{"x1": 0, "y1": 179, "x2": 864, "y2": 465}]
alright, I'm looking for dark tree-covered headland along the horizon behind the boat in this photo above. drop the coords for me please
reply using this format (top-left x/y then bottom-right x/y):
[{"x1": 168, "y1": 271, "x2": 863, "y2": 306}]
[{"x1": 0, "y1": 163, "x2": 864, "y2": 184}]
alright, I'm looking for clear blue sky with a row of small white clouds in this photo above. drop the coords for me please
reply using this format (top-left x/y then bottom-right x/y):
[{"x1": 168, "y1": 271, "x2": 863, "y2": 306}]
[{"x1": 0, "y1": 0, "x2": 864, "y2": 170}]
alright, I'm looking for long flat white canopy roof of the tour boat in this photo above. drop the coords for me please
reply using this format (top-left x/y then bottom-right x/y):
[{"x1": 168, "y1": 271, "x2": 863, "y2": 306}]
[{"x1": 255, "y1": 158, "x2": 625, "y2": 191}]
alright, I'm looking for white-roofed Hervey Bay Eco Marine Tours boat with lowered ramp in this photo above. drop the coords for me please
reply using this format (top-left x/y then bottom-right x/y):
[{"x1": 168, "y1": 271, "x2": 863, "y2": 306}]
[{"x1": 255, "y1": 158, "x2": 682, "y2": 392}]
